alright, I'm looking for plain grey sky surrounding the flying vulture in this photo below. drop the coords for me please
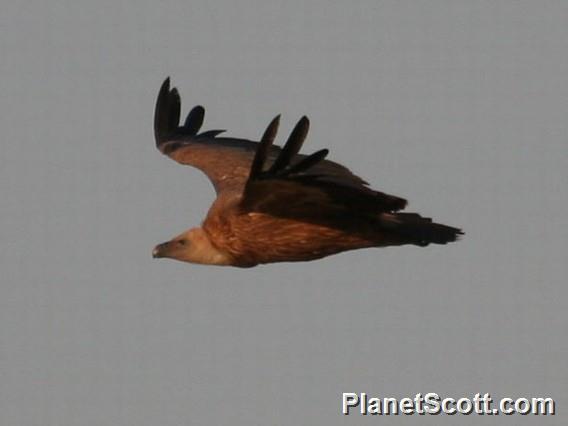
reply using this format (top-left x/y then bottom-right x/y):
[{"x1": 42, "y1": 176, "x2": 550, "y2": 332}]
[{"x1": 0, "y1": 0, "x2": 568, "y2": 426}]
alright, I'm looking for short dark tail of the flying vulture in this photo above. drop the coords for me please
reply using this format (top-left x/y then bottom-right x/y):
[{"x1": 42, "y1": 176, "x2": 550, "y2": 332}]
[{"x1": 381, "y1": 213, "x2": 463, "y2": 247}]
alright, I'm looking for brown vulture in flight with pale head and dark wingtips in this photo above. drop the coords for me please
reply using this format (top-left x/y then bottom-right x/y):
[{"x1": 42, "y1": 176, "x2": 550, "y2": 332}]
[{"x1": 152, "y1": 77, "x2": 463, "y2": 268}]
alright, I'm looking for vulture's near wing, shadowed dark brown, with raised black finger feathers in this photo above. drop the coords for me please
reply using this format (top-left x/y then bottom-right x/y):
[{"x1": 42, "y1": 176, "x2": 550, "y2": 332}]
[{"x1": 241, "y1": 117, "x2": 406, "y2": 222}]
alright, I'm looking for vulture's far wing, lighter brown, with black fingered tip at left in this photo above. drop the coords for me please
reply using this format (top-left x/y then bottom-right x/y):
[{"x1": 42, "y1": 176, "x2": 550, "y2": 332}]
[{"x1": 154, "y1": 78, "x2": 380, "y2": 193}]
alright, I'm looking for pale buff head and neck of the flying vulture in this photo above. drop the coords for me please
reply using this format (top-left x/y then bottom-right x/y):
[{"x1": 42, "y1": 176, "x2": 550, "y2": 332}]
[{"x1": 152, "y1": 228, "x2": 232, "y2": 265}]
